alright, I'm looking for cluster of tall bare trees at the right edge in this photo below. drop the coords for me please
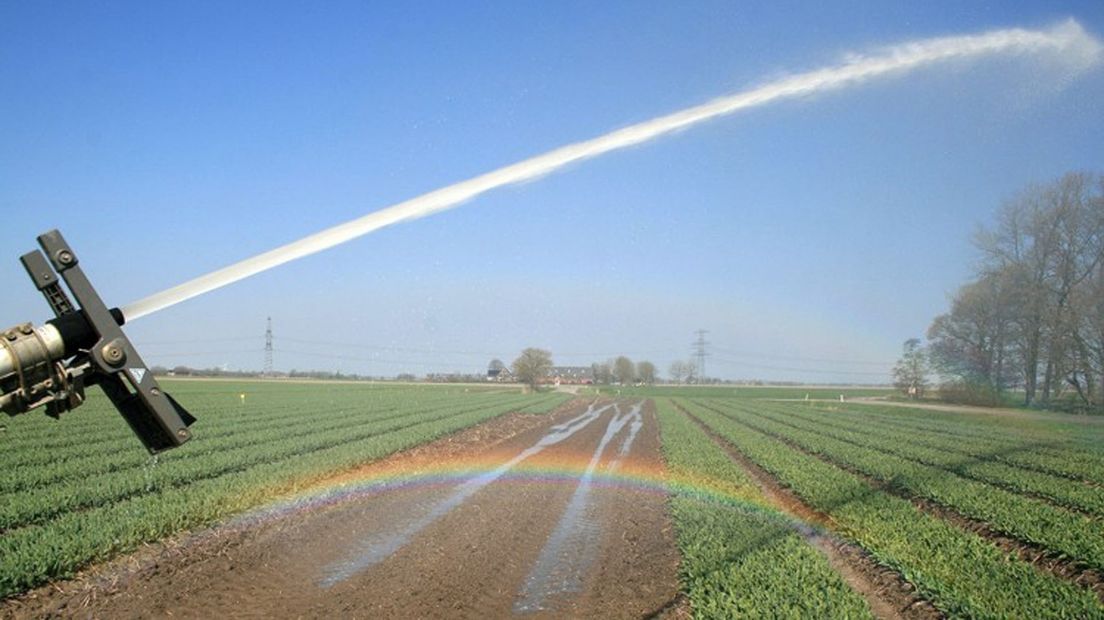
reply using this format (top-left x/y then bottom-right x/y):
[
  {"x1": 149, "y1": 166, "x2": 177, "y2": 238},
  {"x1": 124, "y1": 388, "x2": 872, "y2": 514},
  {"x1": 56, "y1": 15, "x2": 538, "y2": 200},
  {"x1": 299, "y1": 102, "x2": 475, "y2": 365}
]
[{"x1": 922, "y1": 173, "x2": 1104, "y2": 410}]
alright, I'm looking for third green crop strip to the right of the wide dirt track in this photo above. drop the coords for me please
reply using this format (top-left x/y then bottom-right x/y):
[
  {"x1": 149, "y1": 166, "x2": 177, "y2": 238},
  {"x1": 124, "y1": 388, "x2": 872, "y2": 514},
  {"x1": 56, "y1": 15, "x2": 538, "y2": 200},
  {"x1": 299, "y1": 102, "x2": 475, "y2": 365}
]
[{"x1": 702, "y1": 394, "x2": 1104, "y2": 569}]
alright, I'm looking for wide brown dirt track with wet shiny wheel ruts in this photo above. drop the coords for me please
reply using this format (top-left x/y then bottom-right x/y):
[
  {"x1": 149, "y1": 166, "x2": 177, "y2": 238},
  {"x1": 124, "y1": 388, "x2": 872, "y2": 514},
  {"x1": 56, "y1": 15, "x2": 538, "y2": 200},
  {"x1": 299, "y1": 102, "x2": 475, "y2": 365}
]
[{"x1": 3, "y1": 402, "x2": 678, "y2": 618}]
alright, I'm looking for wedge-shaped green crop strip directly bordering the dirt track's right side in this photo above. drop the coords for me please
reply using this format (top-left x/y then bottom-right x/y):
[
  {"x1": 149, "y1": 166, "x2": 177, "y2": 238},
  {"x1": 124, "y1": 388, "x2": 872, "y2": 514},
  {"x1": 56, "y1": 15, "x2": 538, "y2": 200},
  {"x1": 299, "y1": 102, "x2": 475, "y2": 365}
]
[{"x1": 658, "y1": 400, "x2": 873, "y2": 618}]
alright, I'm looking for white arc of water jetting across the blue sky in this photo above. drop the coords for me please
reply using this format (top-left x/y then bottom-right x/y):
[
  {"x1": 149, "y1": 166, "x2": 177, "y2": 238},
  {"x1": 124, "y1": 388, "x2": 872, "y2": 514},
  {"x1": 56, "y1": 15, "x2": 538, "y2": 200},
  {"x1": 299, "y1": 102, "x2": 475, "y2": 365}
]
[{"x1": 116, "y1": 20, "x2": 1102, "y2": 321}]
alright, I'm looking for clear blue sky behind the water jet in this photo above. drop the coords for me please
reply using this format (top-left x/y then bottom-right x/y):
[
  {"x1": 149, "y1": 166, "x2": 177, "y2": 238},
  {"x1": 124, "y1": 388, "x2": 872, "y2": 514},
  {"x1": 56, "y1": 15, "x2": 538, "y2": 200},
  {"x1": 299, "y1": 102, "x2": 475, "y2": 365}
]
[{"x1": 0, "y1": 0, "x2": 1104, "y2": 382}]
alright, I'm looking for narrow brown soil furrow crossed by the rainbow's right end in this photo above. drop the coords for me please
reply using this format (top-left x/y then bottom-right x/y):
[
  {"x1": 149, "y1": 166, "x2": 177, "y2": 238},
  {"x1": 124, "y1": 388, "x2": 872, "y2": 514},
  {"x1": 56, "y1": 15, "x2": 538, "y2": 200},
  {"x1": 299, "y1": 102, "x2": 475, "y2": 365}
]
[{"x1": 679, "y1": 407, "x2": 944, "y2": 620}]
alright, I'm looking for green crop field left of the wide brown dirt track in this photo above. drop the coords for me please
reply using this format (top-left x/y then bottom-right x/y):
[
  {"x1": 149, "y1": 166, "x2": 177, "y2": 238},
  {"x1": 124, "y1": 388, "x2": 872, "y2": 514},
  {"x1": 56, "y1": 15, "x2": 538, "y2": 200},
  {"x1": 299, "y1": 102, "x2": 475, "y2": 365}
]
[{"x1": 0, "y1": 381, "x2": 567, "y2": 596}]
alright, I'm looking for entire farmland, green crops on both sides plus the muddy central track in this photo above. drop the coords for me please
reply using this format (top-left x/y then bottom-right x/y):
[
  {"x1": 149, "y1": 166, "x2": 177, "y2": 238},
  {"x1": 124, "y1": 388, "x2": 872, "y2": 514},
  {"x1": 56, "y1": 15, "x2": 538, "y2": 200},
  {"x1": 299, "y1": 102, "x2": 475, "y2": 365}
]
[{"x1": 0, "y1": 382, "x2": 1104, "y2": 618}]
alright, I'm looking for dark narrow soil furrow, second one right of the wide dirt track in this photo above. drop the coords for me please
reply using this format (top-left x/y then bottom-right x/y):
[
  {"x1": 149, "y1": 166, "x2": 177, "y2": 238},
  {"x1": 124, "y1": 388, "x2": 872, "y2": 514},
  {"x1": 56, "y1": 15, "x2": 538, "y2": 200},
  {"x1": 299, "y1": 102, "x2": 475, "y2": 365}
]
[{"x1": 722, "y1": 403, "x2": 1104, "y2": 601}]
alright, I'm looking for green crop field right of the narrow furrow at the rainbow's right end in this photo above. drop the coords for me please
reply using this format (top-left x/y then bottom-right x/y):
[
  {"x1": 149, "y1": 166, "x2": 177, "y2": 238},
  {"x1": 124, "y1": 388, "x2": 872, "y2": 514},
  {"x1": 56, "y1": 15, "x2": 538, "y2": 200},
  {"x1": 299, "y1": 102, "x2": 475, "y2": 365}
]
[{"x1": 670, "y1": 398, "x2": 1104, "y2": 618}]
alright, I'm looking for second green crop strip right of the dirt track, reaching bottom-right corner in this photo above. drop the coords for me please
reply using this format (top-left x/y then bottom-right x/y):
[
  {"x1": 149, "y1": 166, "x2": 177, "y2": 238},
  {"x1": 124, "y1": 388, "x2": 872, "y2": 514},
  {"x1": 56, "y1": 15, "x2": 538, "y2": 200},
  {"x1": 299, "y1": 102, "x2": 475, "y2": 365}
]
[{"x1": 679, "y1": 400, "x2": 1104, "y2": 618}]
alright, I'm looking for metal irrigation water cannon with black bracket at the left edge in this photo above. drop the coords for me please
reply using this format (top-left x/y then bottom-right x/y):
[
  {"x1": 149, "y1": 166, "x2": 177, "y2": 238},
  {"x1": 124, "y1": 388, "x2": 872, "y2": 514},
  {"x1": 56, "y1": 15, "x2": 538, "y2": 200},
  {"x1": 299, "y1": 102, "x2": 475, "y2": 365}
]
[{"x1": 0, "y1": 231, "x2": 195, "y2": 453}]
